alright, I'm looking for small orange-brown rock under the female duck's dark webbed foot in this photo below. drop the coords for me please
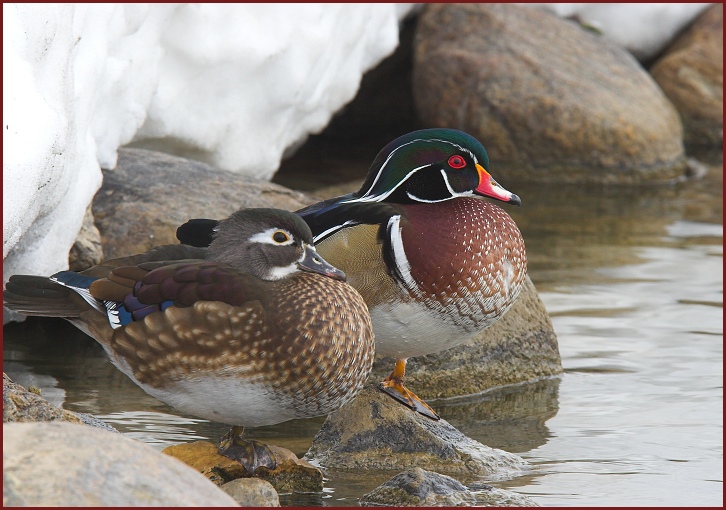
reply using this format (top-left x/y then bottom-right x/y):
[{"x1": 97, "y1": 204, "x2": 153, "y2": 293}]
[{"x1": 163, "y1": 441, "x2": 323, "y2": 493}]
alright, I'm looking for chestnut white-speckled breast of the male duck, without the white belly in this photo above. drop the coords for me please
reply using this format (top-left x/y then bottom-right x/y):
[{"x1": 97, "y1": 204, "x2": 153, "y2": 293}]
[{"x1": 401, "y1": 198, "x2": 527, "y2": 316}]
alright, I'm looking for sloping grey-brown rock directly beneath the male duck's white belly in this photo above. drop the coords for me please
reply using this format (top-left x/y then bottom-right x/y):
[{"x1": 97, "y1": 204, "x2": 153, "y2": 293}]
[{"x1": 371, "y1": 277, "x2": 562, "y2": 399}]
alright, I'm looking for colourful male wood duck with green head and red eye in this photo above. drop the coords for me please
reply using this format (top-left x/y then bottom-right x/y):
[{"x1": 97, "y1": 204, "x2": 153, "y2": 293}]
[{"x1": 177, "y1": 129, "x2": 527, "y2": 419}]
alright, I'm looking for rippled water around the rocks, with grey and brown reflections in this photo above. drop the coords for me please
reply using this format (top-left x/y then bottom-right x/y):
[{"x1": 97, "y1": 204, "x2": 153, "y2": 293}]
[{"x1": 4, "y1": 150, "x2": 723, "y2": 506}]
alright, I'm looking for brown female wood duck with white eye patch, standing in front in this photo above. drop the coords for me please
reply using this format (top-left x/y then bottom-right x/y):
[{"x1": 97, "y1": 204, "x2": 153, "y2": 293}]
[{"x1": 3, "y1": 209, "x2": 374, "y2": 472}]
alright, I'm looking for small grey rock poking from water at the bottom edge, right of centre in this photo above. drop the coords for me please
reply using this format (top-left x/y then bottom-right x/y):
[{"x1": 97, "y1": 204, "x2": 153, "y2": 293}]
[{"x1": 360, "y1": 468, "x2": 476, "y2": 506}]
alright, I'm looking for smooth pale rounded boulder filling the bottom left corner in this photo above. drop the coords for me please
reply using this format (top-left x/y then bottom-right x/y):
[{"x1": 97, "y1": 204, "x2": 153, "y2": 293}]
[{"x1": 3, "y1": 422, "x2": 238, "y2": 507}]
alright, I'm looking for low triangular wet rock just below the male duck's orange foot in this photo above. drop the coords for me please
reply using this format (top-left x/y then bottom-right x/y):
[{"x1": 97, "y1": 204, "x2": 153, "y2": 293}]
[{"x1": 304, "y1": 385, "x2": 527, "y2": 479}]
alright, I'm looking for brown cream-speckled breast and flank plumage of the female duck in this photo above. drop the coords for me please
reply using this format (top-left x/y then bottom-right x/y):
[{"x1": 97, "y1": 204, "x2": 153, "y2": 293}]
[{"x1": 96, "y1": 273, "x2": 373, "y2": 417}]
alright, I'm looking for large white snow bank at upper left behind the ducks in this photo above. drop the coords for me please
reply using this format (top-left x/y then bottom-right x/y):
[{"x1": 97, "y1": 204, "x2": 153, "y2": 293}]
[{"x1": 3, "y1": 4, "x2": 412, "y2": 294}]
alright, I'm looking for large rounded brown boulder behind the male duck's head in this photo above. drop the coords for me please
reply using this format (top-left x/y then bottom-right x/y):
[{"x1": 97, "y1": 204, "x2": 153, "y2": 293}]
[{"x1": 413, "y1": 4, "x2": 685, "y2": 186}]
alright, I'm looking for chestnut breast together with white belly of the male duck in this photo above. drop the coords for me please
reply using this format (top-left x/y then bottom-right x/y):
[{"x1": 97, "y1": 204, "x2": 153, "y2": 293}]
[{"x1": 378, "y1": 198, "x2": 527, "y2": 358}]
